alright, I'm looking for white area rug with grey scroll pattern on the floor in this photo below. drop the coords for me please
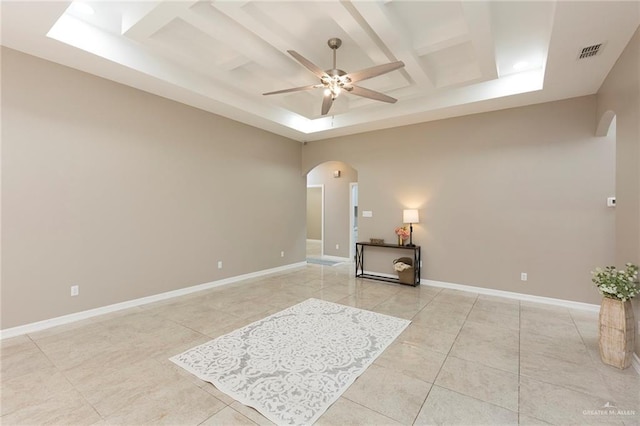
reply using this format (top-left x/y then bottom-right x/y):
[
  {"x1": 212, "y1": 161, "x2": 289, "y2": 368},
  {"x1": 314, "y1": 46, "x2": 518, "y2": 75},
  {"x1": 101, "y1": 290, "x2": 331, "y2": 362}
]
[{"x1": 171, "y1": 299, "x2": 410, "y2": 425}]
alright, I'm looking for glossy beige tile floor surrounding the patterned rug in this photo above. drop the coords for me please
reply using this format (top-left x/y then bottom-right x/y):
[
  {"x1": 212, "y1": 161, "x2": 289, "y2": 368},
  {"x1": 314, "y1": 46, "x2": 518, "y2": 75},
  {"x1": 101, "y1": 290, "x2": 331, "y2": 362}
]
[{"x1": 0, "y1": 265, "x2": 640, "y2": 425}]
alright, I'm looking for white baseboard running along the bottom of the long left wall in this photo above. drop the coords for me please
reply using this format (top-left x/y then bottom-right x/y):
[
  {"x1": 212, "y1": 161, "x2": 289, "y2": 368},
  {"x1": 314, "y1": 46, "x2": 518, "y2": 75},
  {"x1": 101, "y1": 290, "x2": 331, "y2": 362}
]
[{"x1": 0, "y1": 262, "x2": 307, "y2": 340}]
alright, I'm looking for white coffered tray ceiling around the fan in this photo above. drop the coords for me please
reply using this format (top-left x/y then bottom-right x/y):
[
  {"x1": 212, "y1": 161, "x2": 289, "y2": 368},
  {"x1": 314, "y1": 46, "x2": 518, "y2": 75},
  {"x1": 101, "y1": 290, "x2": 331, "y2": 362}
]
[{"x1": 1, "y1": 0, "x2": 640, "y2": 141}]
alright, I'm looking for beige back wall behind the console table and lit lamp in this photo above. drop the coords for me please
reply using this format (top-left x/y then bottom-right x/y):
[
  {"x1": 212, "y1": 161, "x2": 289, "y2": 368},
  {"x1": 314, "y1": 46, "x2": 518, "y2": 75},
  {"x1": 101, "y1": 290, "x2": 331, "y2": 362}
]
[{"x1": 302, "y1": 96, "x2": 615, "y2": 303}]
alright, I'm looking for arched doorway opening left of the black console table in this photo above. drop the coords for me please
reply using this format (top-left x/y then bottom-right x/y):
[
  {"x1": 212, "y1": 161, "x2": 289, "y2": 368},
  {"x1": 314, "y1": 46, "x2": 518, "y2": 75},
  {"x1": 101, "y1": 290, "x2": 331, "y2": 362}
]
[{"x1": 307, "y1": 160, "x2": 358, "y2": 261}]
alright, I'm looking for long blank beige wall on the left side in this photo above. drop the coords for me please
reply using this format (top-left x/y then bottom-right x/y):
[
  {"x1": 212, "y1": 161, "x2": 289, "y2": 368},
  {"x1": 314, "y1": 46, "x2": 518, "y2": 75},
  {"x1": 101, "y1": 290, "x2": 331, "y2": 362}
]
[{"x1": 1, "y1": 48, "x2": 306, "y2": 329}]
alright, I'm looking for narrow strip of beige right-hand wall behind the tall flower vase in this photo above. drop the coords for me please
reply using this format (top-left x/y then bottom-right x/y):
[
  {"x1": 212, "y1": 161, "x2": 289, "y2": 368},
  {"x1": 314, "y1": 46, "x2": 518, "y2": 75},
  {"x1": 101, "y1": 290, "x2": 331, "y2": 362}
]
[{"x1": 597, "y1": 25, "x2": 640, "y2": 356}]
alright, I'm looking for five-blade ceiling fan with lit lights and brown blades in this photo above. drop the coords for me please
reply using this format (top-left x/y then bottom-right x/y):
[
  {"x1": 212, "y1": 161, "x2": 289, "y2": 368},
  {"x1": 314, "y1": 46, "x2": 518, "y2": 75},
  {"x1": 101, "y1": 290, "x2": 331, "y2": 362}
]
[{"x1": 263, "y1": 37, "x2": 404, "y2": 115}]
